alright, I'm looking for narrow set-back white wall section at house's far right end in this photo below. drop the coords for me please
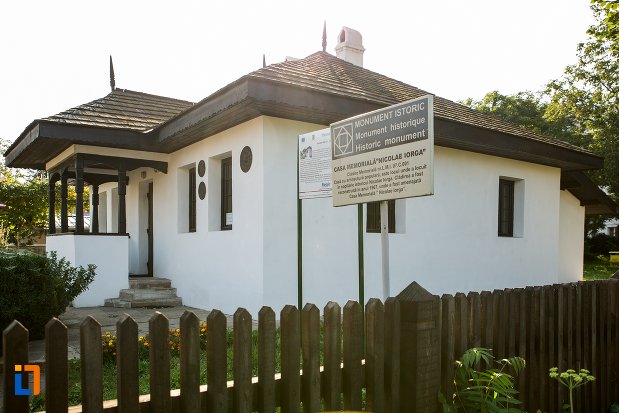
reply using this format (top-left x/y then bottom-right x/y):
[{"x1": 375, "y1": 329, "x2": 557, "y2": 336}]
[{"x1": 559, "y1": 191, "x2": 585, "y2": 283}]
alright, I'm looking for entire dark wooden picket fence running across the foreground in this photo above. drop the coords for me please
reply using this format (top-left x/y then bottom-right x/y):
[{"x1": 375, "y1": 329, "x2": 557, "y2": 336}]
[{"x1": 3, "y1": 280, "x2": 619, "y2": 413}]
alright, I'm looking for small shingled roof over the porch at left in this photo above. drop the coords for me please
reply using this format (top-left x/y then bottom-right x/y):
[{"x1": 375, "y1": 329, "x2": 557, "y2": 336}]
[{"x1": 42, "y1": 89, "x2": 193, "y2": 132}]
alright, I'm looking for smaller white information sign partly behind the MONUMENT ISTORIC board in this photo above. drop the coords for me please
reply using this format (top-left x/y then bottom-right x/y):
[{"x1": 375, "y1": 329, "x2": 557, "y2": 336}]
[{"x1": 299, "y1": 128, "x2": 331, "y2": 199}]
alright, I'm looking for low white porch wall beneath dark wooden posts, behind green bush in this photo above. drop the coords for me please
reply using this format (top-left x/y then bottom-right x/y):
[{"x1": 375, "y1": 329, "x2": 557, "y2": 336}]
[{"x1": 46, "y1": 234, "x2": 129, "y2": 307}]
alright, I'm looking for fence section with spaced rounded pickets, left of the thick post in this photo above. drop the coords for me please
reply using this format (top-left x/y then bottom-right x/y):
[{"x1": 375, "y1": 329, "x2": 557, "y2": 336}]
[{"x1": 3, "y1": 299, "x2": 400, "y2": 413}]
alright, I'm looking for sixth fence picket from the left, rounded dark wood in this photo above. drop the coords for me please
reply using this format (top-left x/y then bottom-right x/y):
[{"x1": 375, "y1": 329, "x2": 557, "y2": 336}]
[{"x1": 180, "y1": 311, "x2": 200, "y2": 413}]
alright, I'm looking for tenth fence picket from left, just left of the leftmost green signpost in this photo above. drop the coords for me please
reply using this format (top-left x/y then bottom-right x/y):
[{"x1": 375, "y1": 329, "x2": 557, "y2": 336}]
[{"x1": 280, "y1": 305, "x2": 301, "y2": 413}]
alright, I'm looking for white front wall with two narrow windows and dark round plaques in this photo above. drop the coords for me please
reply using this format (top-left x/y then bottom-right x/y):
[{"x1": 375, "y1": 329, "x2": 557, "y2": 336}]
[{"x1": 151, "y1": 118, "x2": 264, "y2": 313}]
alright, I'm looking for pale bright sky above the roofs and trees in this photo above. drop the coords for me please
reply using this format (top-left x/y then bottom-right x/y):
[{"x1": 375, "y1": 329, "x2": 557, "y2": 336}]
[{"x1": 0, "y1": 0, "x2": 593, "y2": 141}]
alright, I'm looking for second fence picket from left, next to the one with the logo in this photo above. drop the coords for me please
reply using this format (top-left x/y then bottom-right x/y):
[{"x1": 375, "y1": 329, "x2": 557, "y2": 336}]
[{"x1": 45, "y1": 317, "x2": 69, "y2": 413}]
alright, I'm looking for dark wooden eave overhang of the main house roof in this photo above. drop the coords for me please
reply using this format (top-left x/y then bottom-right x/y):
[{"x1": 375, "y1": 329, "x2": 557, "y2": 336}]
[{"x1": 154, "y1": 77, "x2": 603, "y2": 171}]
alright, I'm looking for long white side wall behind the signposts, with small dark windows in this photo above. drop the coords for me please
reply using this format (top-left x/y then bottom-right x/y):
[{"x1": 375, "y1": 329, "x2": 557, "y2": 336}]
[{"x1": 303, "y1": 147, "x2": 568, "y2": 303}]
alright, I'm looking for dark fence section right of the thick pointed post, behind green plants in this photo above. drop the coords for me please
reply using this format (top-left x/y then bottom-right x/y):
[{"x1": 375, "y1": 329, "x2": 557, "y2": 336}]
[{"x1": 440, "y1": 280, "x2": 619, "y2": 413}]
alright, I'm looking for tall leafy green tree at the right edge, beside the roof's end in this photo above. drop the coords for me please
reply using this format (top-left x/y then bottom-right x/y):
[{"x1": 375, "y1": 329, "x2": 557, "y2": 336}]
[{"x1": 544, "y1": 0, "x2": 619, "y2": 196}]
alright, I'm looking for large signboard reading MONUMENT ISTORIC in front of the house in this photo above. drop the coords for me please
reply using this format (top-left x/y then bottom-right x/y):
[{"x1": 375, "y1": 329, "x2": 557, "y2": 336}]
[{"x1": 331, "y1": 95, "x2": 434, "y2": 206}]
